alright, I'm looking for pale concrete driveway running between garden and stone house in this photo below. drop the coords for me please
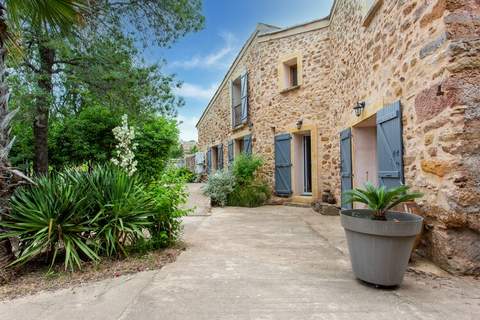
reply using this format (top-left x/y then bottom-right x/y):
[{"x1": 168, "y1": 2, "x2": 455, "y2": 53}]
[{"x1": 0, "y1": 206, "x2": 480, "y2": 320}]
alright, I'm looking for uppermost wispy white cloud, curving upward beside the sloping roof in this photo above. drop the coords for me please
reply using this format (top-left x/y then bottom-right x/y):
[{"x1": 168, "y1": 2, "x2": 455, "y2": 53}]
[{"x1": 171, "y1": 32, "x2": 238, "y2": 69}]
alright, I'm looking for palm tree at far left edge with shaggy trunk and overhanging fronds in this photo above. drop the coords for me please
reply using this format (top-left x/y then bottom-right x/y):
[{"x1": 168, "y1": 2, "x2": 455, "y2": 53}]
[{"x1": 0, "y1": 0, "x2": 86, "y2": 276}]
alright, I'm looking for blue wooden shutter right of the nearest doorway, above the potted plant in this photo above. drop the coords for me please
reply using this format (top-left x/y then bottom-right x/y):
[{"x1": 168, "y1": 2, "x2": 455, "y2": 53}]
[{"x1": 377, "y1": 101, "x2": 404, "y2": 188}]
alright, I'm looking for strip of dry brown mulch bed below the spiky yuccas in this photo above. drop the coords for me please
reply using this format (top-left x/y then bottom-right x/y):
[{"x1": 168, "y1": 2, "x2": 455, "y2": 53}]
[{"x1": 0, "y1": 243, "x2": 186, "y2": 301}]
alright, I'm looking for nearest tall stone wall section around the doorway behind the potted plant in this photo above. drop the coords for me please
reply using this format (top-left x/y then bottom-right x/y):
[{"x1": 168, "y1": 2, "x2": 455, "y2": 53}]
[{"x1": 320, "y1": 0, "x2": 480, "y2": 273}]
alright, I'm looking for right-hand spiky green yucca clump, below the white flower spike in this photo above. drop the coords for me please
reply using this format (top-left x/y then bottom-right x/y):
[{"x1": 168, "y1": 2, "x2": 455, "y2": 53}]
[{"x1": 88, "y1": 166, "x2": 154, "y2": 256}]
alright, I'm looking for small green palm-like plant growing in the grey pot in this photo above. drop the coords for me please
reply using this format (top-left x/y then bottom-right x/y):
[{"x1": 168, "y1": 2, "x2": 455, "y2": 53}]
[{"x1": 344, "y1": 182, "x2": 423, "y2": 220}]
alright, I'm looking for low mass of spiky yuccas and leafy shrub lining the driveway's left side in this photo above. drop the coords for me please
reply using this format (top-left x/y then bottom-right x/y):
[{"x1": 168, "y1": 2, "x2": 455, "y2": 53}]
[{"x1": 0, "y1": 166, "x2": 187, "y2": 270}]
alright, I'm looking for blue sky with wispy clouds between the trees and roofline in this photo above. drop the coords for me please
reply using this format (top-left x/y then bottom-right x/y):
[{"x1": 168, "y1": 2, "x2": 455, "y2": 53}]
[{"x1": 144, "y1": 0, "x2": 333, "y2": 140}]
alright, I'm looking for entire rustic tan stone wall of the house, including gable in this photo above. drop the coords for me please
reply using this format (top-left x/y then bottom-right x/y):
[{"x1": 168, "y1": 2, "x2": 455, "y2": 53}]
[{"x1": 198, "y1": 0, "x2": 480, "y2": 274}]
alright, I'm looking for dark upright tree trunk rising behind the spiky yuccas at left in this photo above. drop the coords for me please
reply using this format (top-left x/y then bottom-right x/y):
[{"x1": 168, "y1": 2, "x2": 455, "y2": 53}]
[{"x1": 33, "y1": 40, "x2": 55, "y2": 174}]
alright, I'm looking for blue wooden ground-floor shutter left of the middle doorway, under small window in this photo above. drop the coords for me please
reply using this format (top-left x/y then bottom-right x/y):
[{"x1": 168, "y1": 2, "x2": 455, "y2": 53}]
[{"x1": 275, "y1": 134, "x2": 292, "y2": 196}]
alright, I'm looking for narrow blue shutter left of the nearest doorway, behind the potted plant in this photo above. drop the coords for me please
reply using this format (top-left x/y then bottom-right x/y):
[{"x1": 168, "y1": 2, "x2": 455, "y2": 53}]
[{"x1": 340, "y1": 128, "x2": 353, "y2": 209}]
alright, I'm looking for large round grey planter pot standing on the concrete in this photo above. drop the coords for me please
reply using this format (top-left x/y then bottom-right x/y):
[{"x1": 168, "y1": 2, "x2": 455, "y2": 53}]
[{"x1": 340, "y1": 209, "x2": 423, "y2": 286}]
